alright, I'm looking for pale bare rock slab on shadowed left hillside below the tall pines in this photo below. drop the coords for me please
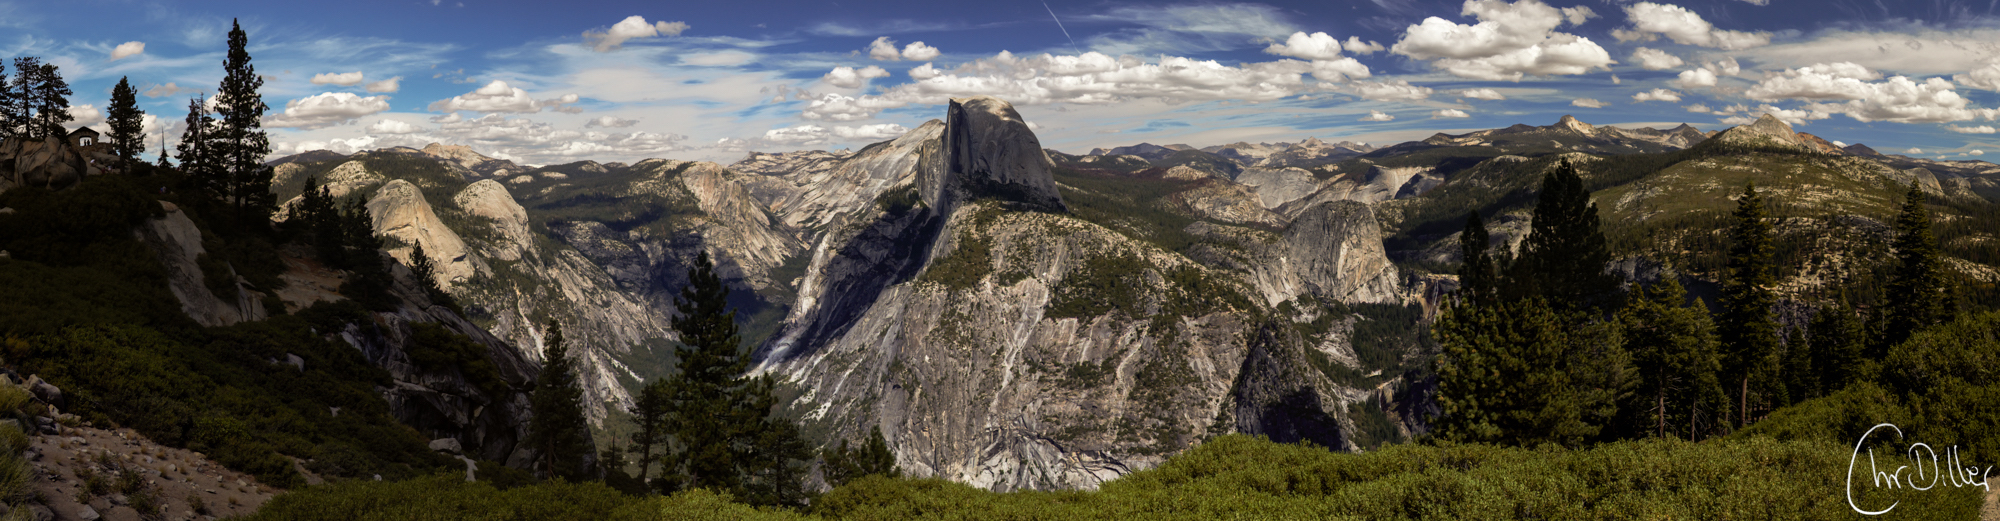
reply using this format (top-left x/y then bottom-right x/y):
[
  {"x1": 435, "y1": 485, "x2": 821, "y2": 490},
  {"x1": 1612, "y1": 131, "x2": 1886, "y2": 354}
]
[{"x1": 132, "y1": 200, "x2": 266, "y2": 327}]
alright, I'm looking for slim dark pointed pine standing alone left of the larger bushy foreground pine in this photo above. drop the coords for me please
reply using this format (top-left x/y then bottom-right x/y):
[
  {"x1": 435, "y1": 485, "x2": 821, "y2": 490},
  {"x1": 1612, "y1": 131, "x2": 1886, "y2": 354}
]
[{"x1": 528, "y1": 321, "x2": 590, "y2": 481}]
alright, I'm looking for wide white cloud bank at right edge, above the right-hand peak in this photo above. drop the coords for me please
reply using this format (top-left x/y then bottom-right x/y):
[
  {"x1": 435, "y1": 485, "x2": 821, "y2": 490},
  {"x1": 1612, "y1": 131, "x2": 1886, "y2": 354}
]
[{"x1": 1744, "y1": 62, "x2": 2000, "y2": 122}]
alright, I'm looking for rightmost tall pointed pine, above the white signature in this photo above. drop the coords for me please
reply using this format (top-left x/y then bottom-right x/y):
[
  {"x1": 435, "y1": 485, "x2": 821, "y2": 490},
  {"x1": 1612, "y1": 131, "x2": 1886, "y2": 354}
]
[{"x1": 1876, "y1": 180, "x2": 1952, "y2": 353}]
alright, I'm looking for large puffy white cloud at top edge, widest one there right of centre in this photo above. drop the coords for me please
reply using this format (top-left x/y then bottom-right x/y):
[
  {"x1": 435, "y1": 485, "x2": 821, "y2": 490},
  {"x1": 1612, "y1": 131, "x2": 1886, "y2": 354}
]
[{"x1": 1390, "y1": 0, "x2": 1614, "y2": 80}]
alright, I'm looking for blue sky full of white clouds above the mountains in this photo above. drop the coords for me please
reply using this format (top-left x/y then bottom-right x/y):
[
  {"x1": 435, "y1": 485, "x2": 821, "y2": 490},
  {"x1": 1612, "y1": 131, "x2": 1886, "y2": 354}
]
[{"x1": 11, "y1": 0, "x2": 2000, "y2": 164}]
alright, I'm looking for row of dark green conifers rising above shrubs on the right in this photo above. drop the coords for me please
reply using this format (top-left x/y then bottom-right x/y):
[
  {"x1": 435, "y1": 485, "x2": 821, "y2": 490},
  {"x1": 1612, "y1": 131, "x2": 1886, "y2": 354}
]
[{"x1": 1432, "y1": 162, "x2": 1954, "y2": 447}]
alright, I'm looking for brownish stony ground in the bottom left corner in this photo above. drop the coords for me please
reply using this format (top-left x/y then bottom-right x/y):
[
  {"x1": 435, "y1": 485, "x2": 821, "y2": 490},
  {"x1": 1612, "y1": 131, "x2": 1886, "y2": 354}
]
[{"x1": 26, "y1": 427, "x2": 290, "y2": 521}]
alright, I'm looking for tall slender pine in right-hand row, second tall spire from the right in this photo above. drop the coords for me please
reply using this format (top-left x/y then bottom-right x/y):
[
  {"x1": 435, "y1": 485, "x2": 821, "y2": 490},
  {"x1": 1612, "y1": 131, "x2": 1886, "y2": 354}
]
[{"x1": 1716, "y1": 184, "x2": 1784, "y2": 427}]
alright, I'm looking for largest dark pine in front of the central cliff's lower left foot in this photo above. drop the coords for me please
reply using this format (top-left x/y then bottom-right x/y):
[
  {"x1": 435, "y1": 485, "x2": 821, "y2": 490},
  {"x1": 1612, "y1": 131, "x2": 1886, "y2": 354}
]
[{"x1": 654, "y1": 252, "x2": 810, "y2": 505}]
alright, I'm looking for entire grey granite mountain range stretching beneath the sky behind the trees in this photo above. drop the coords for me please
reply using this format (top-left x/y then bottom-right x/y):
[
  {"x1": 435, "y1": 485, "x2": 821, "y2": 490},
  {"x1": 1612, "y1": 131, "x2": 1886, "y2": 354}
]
[{"x1": 184, "y1": 98, "x2": 2000, "y2": 491}]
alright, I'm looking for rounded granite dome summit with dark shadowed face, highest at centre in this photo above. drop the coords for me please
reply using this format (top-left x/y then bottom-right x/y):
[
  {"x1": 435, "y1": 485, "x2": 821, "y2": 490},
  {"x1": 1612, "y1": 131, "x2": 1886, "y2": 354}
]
[{"x1": 916, "y1": 96, "x2": 1066, "y2": 214}]
